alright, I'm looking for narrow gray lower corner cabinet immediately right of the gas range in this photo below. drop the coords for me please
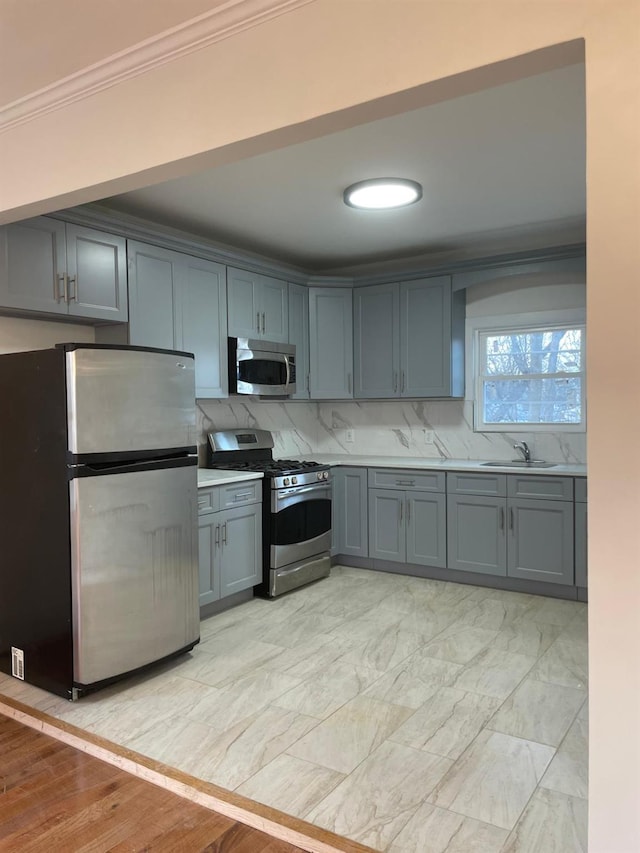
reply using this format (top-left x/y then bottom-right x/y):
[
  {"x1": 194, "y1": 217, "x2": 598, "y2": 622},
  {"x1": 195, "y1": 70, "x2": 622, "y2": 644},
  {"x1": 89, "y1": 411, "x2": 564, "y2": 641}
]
[{"x1": 331, "y1": 467, "x2": 369, "y2": 557}]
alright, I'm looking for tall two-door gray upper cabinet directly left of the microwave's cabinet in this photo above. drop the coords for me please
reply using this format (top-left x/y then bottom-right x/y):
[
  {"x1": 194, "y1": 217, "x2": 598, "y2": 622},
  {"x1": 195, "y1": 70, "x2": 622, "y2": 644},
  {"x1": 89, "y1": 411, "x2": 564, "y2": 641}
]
[{"x1": 125, "y1": 241, "x2": 228, "y2": 398}]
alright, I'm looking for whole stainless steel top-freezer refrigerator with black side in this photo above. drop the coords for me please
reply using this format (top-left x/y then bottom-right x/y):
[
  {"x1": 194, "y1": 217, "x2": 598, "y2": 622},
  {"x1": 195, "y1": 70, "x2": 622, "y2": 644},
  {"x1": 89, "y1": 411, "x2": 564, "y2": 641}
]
[{"x1": 0, "y1": 344, "x2": 200, "y2": 699}]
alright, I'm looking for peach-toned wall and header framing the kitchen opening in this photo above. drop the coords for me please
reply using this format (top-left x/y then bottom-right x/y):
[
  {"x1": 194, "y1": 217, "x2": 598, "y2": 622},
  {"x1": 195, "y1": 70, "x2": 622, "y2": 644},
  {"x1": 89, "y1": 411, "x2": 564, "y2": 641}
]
[{"x1": 0, "y1": 5, "x2": 640, "y2": 853}]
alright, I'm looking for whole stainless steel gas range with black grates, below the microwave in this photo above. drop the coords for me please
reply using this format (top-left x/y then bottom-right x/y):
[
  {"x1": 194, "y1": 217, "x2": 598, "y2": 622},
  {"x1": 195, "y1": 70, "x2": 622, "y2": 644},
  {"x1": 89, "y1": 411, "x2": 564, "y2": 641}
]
[{"x1": 207, "y1": 429, "x2": 331, "y2": 598}]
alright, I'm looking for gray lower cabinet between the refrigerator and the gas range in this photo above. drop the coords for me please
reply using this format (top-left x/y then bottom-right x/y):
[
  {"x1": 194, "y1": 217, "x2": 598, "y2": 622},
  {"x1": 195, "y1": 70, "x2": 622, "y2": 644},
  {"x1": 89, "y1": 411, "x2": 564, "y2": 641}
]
[{"x1": 198, "y1": 481, "x2": 262, "y2": 607}]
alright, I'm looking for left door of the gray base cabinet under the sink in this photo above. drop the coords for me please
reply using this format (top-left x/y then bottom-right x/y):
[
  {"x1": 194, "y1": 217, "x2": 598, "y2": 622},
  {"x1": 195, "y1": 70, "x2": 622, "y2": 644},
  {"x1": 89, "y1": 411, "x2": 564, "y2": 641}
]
[{"x1": 447, "y1": 495, "x2": 507, "y2": 576}]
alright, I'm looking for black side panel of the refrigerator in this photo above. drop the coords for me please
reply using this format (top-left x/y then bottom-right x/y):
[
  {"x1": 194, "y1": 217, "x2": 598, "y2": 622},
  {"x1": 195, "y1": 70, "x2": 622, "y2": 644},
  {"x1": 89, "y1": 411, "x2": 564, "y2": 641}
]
[{"x1": 0, "y1": 350, "x2": 73, "y2": 698}]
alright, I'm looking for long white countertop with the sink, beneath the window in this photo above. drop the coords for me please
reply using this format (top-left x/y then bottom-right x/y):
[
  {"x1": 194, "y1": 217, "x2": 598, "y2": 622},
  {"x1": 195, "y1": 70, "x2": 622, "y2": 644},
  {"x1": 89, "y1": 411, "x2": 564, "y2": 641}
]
[{"x1": 294, "y1": 453, "x2": 587, "y2": 477}]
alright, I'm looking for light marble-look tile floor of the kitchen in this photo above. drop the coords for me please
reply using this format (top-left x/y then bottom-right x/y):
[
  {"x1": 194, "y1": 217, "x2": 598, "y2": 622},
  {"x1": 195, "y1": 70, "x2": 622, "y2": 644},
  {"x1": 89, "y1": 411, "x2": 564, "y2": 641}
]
[{"x1": 0, "y1": 566, "x2": 588, "y2": 853}]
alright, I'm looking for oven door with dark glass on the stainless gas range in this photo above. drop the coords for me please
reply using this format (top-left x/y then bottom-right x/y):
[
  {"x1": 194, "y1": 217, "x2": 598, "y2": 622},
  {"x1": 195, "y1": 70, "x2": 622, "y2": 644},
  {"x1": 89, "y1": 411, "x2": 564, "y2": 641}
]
[{"x1": 269, "y1": 480, "x2": 331, "y2": 569}]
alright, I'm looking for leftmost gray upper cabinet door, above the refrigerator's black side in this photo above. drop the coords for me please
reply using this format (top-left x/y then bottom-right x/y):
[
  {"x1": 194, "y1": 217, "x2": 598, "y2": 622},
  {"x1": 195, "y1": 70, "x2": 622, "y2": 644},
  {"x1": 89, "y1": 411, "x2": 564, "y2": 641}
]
[{"x1": 0, "y1": 216, "x2": 68, "y2": 314}]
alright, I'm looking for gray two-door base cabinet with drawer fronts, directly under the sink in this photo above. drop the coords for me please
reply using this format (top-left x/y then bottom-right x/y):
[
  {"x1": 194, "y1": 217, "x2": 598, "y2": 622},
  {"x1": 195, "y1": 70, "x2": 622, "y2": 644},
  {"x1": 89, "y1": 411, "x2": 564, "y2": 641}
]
[{"x1": 447, "y1": 473, "x2": 574, "y2": 585}]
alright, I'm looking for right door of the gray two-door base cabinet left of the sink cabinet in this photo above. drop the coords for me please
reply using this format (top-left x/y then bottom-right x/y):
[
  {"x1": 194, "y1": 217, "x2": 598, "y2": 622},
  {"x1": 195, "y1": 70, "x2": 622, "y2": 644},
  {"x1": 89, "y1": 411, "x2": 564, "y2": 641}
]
[{"x1": 406, "y1": 492, "x2": 447, "y2": 568}]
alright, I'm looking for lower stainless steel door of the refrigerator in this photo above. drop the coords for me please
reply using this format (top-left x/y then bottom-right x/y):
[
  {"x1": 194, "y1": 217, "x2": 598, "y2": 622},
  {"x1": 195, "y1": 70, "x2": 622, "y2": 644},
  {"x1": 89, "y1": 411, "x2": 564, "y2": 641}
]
[{"x1": 69, "y1": 466, "x2": 200, "y2": 685}]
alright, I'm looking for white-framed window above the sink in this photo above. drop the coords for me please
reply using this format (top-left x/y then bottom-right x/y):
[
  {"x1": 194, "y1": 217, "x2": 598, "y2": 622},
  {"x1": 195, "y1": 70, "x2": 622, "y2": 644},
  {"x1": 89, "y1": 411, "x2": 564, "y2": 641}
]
[{"x1": 475, "y1": 324, "x2": 585, "y2": 432}]
